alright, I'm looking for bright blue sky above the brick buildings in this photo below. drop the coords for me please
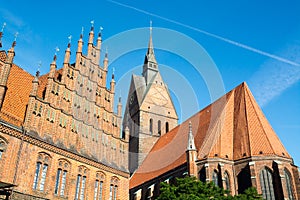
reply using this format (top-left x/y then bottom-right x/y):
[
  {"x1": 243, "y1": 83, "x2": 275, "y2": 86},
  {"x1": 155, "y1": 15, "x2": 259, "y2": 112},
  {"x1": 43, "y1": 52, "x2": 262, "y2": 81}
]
[{"x1": 0, "y1": 0, "x2": 300, "y2": 165}]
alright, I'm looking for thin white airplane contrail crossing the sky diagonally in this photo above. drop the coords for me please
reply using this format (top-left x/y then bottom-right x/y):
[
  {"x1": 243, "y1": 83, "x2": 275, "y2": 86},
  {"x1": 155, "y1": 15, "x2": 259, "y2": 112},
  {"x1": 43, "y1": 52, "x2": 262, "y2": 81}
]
[{"x1": 106, "y1": 0, "x2": 300, "y2": 67}]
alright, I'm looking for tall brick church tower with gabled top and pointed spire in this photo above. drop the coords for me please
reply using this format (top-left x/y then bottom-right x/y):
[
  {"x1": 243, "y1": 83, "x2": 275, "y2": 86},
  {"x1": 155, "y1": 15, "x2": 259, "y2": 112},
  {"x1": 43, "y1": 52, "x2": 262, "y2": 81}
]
[{"x1": 123, "y1": 27, "x2": 178, "y2": 173}]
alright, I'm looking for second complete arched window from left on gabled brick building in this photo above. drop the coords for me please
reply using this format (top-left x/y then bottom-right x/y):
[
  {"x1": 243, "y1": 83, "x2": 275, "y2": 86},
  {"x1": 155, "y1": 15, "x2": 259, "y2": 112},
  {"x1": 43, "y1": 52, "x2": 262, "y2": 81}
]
[{"x1": 54, "y1": 160, "x2": 70, "y2": 196}]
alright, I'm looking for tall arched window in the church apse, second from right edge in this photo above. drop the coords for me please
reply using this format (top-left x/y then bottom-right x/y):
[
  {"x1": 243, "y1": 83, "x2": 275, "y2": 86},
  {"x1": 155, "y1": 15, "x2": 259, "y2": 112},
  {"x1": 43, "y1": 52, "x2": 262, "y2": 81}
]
[{"x1": 260, "y1": 168, "x2": 275, "y2": 200}]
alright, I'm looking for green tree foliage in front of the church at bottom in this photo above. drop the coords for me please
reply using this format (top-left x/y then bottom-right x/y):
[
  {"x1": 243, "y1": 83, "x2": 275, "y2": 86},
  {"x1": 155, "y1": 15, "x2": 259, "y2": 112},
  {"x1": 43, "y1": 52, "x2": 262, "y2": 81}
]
[{"x1": 157, "y1": 177, "x2": 262, "y2": 200}]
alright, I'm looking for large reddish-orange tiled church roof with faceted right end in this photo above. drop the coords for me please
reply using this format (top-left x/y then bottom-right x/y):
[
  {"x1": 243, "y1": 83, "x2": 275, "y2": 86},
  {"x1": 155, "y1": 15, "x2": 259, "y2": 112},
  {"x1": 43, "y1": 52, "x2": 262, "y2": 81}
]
[{"x1": 130, "y1": 83, "x2": 291, "y2": 188}]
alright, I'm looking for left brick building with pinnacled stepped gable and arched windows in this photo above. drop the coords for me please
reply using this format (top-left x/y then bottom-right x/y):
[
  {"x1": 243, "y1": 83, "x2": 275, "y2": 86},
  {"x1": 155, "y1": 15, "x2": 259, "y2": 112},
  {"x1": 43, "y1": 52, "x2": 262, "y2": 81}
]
[{"x1": 0, "y1": 26, "x2": 129, "y2": 199}]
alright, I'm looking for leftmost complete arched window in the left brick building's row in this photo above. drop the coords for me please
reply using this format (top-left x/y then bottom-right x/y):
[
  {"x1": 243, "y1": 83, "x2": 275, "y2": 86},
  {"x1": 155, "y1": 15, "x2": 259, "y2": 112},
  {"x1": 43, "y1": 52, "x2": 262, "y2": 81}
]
[{"x1": 33, "y1": 153, "x2": 50, "y2": 191}]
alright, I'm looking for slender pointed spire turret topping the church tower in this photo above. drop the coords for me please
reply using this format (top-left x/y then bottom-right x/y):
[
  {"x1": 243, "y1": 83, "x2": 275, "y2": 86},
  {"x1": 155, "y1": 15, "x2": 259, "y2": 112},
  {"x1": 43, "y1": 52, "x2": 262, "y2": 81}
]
[{"x1": 143, "y1": 21, "x2": 158, "y2": 85}]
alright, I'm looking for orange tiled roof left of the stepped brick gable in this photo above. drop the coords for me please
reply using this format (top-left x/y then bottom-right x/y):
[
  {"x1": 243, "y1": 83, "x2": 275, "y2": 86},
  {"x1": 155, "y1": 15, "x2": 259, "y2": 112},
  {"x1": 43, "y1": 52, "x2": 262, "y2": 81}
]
[{"x1": 0, "y1": 52, "x2": 34, "y2": 126}]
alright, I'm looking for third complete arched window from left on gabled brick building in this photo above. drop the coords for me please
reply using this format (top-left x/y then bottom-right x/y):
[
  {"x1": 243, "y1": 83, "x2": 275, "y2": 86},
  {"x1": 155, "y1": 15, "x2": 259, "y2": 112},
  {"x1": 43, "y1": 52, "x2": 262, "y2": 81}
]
[{"x1": 75, "y1": 166, "x2": 87, "y2": 200}]
